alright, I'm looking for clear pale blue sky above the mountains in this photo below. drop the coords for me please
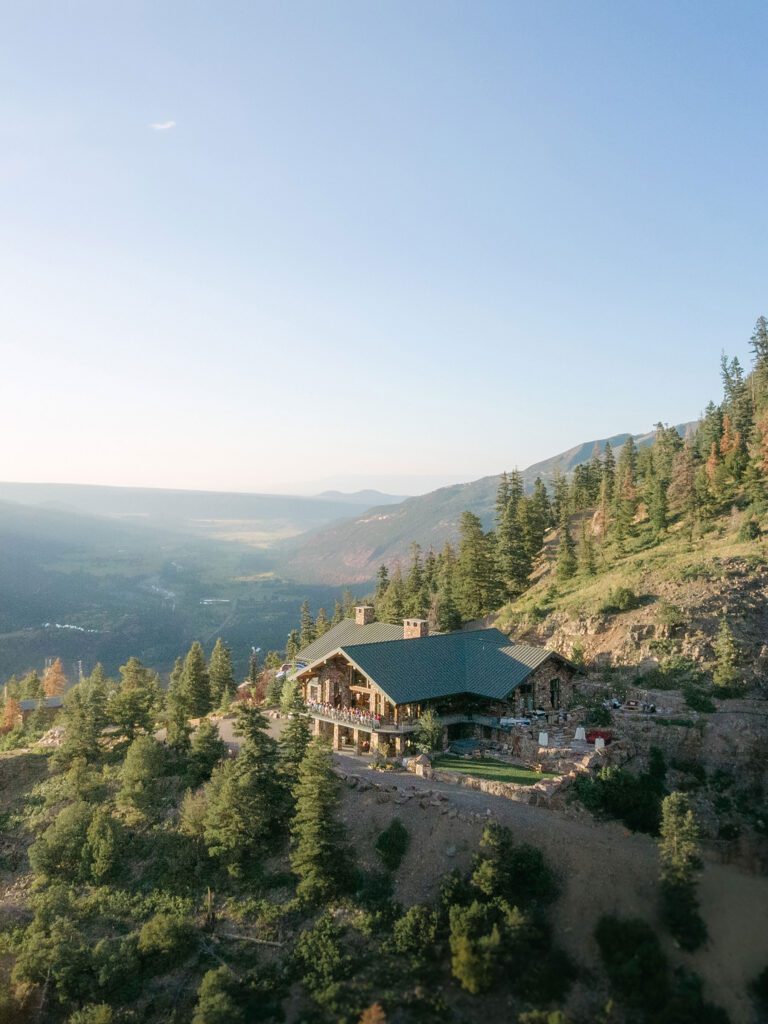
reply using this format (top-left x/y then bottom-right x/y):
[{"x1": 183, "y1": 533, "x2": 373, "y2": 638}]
[{"x1": 0, "y1": 0, "x2": 768, "y2": 494}]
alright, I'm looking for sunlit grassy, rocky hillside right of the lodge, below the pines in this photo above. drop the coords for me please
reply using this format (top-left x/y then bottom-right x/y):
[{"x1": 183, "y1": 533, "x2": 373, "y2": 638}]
[{"x1": 497, "y1": 512, "x2": 768, "y2": 683}]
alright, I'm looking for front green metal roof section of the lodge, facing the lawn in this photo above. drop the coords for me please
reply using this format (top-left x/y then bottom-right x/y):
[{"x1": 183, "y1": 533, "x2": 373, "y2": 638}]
[{"x1": 301, "y1": 629, "x2": 568, "y2": 705}]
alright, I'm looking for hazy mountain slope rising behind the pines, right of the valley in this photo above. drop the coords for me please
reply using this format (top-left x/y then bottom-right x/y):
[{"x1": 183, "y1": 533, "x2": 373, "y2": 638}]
[{"x1": 278, "y1": 423, "x2": 695, "y2": 584}]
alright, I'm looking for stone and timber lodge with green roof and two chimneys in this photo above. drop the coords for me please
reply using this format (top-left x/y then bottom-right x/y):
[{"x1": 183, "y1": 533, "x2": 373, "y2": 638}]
[{"x1": 294, "y1": 605, "x2": 578, "y2": 754}]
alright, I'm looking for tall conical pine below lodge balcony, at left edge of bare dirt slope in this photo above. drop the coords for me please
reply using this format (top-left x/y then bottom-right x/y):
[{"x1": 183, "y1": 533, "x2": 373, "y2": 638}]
[{"x1": 291, "y1": 739, "x2": 347, "y2": 903}]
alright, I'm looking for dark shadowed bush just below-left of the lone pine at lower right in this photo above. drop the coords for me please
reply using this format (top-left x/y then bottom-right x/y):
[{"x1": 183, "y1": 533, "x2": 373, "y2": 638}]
[{"x1": 595, "y1": 915, "x2": 669, "y2": 1011}]
